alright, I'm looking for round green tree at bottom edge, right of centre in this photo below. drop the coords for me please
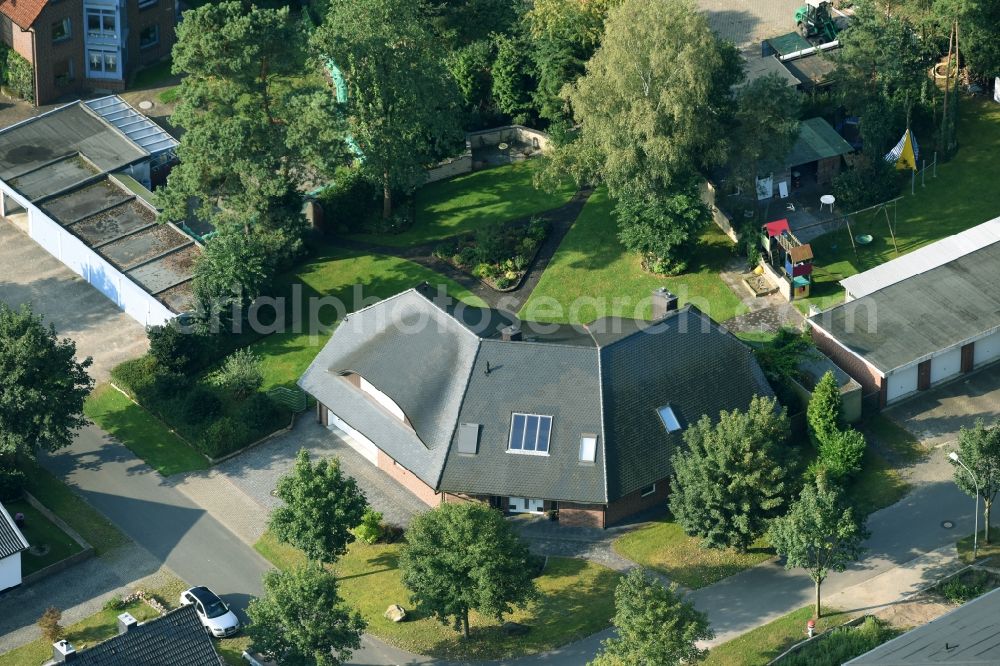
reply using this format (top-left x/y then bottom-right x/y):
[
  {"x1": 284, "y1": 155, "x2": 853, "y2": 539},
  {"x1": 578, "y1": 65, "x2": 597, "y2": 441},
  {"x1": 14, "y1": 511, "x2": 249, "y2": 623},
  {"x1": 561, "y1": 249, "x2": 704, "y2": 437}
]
[{"x1": 590, "y1": 567, "x2": 715, "y2": 666}]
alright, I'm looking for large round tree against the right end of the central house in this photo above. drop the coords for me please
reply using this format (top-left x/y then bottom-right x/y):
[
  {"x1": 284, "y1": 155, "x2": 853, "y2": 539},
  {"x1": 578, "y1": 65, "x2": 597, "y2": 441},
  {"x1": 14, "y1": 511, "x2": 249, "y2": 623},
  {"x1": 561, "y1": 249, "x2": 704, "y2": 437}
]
[{"x1": 670, "y1": 396, "x2": 789, "y2": 551}]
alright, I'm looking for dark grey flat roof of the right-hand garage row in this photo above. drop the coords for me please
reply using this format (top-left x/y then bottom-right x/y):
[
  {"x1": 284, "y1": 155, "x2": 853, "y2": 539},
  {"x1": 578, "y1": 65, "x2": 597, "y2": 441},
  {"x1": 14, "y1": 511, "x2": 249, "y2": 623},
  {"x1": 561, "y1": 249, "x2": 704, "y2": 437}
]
[{"x1": 809, "y1": 243, "x2": 1000, "y2": 373}]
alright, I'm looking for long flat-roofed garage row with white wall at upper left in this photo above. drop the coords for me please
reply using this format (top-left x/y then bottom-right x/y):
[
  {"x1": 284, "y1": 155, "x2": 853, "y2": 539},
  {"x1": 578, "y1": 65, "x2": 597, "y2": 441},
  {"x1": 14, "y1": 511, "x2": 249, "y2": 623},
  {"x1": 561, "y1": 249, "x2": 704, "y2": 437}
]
[{"x1": 0, "y1": 95, "x2": 193, "y2": 325}]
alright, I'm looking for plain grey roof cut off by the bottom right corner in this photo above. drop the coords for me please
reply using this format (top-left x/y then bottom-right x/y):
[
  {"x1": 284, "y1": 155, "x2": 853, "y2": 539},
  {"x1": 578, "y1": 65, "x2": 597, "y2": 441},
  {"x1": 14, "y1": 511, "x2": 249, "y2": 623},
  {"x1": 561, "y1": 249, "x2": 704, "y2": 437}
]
[{"x1": 844, "y1": 589, "x2": 1000, "y2": 666}]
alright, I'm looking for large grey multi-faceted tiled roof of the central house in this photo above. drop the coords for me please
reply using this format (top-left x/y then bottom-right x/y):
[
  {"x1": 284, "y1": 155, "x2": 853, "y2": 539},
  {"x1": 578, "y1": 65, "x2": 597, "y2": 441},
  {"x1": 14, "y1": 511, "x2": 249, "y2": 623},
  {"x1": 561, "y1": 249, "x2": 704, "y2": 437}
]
[{"x1": 299, "y1": 289, "x2": 772, "y2": 503}]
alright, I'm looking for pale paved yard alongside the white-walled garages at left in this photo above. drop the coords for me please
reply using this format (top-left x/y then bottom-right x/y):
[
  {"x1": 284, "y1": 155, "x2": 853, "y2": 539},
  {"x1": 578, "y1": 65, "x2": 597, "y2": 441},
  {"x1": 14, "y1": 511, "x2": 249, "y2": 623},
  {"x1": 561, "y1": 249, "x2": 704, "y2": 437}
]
[{"x1": 0, "y1": 218, "x2": 147, "y2": 381}]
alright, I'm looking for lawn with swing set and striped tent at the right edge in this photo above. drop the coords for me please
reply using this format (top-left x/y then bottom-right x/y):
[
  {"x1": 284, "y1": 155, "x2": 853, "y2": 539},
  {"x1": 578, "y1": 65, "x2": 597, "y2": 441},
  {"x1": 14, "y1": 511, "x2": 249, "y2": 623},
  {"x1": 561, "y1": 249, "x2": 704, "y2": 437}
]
[{"x1": 797, "y1": 98, "x2": 1000, "y2": 308}]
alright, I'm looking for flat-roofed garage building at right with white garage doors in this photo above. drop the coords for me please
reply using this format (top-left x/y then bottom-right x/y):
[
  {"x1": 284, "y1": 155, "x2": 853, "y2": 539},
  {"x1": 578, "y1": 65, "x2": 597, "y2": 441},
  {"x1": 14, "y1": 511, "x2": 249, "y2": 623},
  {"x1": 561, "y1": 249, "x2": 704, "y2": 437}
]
[{"x1": 809, "y1": 220, "x2": 1000, "y2": 405}]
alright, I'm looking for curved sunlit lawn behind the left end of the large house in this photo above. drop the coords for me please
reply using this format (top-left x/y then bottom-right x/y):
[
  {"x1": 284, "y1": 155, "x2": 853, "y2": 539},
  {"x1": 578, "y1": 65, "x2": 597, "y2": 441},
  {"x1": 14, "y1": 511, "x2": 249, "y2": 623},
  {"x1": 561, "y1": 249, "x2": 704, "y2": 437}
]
[{"x1": 253, "y1": 247, "x2": 485, "y2": 390}]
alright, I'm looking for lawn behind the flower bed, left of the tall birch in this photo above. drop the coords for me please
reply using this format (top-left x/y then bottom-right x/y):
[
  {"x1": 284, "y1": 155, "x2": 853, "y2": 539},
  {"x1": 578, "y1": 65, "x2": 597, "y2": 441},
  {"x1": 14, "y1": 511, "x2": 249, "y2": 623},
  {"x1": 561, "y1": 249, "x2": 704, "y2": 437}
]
[{"x1": 352, "y1": 160, "x2": 576, "y2": 247}]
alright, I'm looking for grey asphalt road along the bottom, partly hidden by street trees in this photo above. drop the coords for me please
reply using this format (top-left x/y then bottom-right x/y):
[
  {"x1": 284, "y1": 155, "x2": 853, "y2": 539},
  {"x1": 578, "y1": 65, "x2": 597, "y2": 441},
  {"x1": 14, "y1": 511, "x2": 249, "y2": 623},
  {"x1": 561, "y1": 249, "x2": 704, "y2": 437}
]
[{"x1": 43, "y1": 426, "x2": 974, "y2": 666}]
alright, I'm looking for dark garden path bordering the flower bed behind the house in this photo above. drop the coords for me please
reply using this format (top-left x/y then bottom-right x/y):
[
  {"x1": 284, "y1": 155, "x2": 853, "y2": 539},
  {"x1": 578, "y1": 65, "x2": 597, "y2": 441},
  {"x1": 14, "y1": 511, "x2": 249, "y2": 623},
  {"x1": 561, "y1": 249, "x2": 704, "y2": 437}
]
[{"x1": 338, "y1": 188, "x2": 593, "y2": 313}]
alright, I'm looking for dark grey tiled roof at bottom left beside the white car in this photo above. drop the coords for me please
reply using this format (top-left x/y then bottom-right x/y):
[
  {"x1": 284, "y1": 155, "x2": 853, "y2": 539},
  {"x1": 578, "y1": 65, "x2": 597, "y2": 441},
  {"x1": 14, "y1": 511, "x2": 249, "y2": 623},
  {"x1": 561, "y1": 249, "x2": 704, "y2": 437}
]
[{"x1": 73, "y1": 606, "x2": 223, "y2": 666}]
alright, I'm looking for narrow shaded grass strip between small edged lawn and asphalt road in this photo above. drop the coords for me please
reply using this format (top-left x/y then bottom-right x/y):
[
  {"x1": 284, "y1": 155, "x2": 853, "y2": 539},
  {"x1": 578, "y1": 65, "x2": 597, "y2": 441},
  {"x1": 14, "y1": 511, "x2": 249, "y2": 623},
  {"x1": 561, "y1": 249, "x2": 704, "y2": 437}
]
[{"x1": 23, "y1": 463, "x2": 128, "y2": 555}]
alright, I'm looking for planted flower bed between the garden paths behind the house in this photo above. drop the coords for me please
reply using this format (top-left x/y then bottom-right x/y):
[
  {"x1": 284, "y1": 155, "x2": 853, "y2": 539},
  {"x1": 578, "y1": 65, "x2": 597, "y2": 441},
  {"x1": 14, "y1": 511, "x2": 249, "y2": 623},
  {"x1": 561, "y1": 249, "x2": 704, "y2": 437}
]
[{"x1": 434, "y1": 218, "x2": 549, "y2": 291}]
